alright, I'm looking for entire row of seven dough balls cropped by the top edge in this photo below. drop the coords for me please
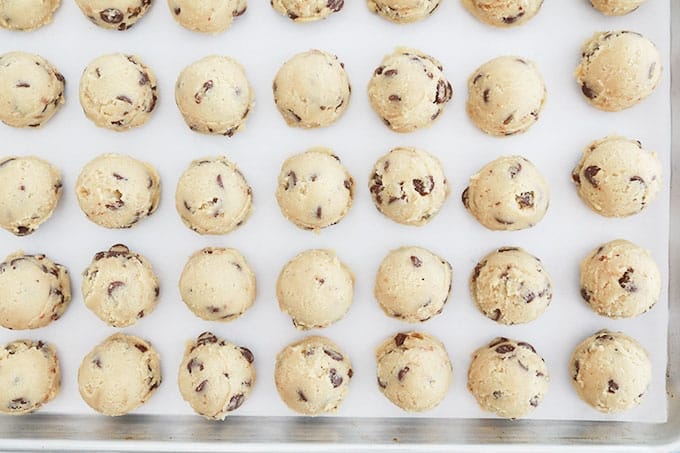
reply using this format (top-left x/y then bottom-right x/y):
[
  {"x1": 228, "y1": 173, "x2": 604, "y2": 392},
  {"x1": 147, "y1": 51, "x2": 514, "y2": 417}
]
[{"x1": 0, "y1": 0, "x2": 644, "y2": 34}]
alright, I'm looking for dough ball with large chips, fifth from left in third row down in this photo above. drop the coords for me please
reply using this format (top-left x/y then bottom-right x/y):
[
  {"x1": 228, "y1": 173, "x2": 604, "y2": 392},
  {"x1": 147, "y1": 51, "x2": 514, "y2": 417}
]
[{"x1": 368, "y1": 147, "x2": 449, "y2": 226}]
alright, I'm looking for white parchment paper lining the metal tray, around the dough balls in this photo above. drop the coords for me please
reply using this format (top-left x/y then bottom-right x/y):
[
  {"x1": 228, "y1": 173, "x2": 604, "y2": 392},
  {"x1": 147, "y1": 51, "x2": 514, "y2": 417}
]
[{"x1": 0, "y1": 1, "x2": 670, "y2": 422}]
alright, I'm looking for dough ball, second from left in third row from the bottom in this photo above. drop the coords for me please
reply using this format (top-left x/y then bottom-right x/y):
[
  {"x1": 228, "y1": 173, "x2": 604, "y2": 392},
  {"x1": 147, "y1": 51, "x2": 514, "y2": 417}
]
[{"x1": 76, "y1": 154, "x2": 161, "y2": 228}]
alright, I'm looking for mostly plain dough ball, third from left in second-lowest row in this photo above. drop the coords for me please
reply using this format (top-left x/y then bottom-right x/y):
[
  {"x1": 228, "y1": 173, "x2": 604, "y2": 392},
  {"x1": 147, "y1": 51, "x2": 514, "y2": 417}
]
[{"x1": 179, "y1": 247, "x2": 257, "y2": 321}]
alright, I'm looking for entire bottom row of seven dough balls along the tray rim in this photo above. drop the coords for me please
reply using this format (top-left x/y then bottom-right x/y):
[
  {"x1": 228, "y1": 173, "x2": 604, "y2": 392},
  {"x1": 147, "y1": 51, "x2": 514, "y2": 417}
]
[{"x1": 0, "y1": 330, "x2": 652, "y2": 420}]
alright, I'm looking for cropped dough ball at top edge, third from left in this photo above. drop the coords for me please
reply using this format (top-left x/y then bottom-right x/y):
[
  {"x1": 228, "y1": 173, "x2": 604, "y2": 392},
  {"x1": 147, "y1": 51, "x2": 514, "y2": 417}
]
[{"x1": 168, "y1": 0, "x2": 247, "y2": 34}]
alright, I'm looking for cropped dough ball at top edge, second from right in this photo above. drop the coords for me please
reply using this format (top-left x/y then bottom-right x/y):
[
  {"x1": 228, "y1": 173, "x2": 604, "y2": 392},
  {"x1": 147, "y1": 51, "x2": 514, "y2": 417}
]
[{"x1": 462, "y1": 0, "x2": 543, "y2": 28}]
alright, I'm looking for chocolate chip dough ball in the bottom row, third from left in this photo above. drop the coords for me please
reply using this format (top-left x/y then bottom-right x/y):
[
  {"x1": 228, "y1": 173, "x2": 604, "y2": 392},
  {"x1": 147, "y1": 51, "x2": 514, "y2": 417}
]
[{"x1": 177, "y1": 332, "x2": 255, "y2": 420}]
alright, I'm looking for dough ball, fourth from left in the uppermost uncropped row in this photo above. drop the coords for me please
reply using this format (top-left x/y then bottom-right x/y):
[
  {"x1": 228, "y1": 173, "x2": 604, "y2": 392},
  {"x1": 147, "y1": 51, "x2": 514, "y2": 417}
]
[{"x1": 273, "y1": 49, "x2": 352, "y2": 128}]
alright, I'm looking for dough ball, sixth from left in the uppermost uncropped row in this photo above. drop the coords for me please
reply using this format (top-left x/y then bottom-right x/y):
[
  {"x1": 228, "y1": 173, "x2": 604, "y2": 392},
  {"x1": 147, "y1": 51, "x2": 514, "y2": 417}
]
[{"x1": 467, "y1": 55, "x2": 547, "y2": 137}]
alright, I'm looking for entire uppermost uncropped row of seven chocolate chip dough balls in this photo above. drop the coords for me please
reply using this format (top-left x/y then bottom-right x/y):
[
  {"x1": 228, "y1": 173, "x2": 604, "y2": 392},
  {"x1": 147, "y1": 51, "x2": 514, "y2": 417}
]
[{"x1": 0, "y1": 31, "x2": 662, "y2": 136}]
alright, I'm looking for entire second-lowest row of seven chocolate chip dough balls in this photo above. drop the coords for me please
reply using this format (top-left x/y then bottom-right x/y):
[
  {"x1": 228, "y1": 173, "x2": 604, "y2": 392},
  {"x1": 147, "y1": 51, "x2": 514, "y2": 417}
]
[{"x1": 0, "y1": 239, "x2": 661, "y2": 330}]
